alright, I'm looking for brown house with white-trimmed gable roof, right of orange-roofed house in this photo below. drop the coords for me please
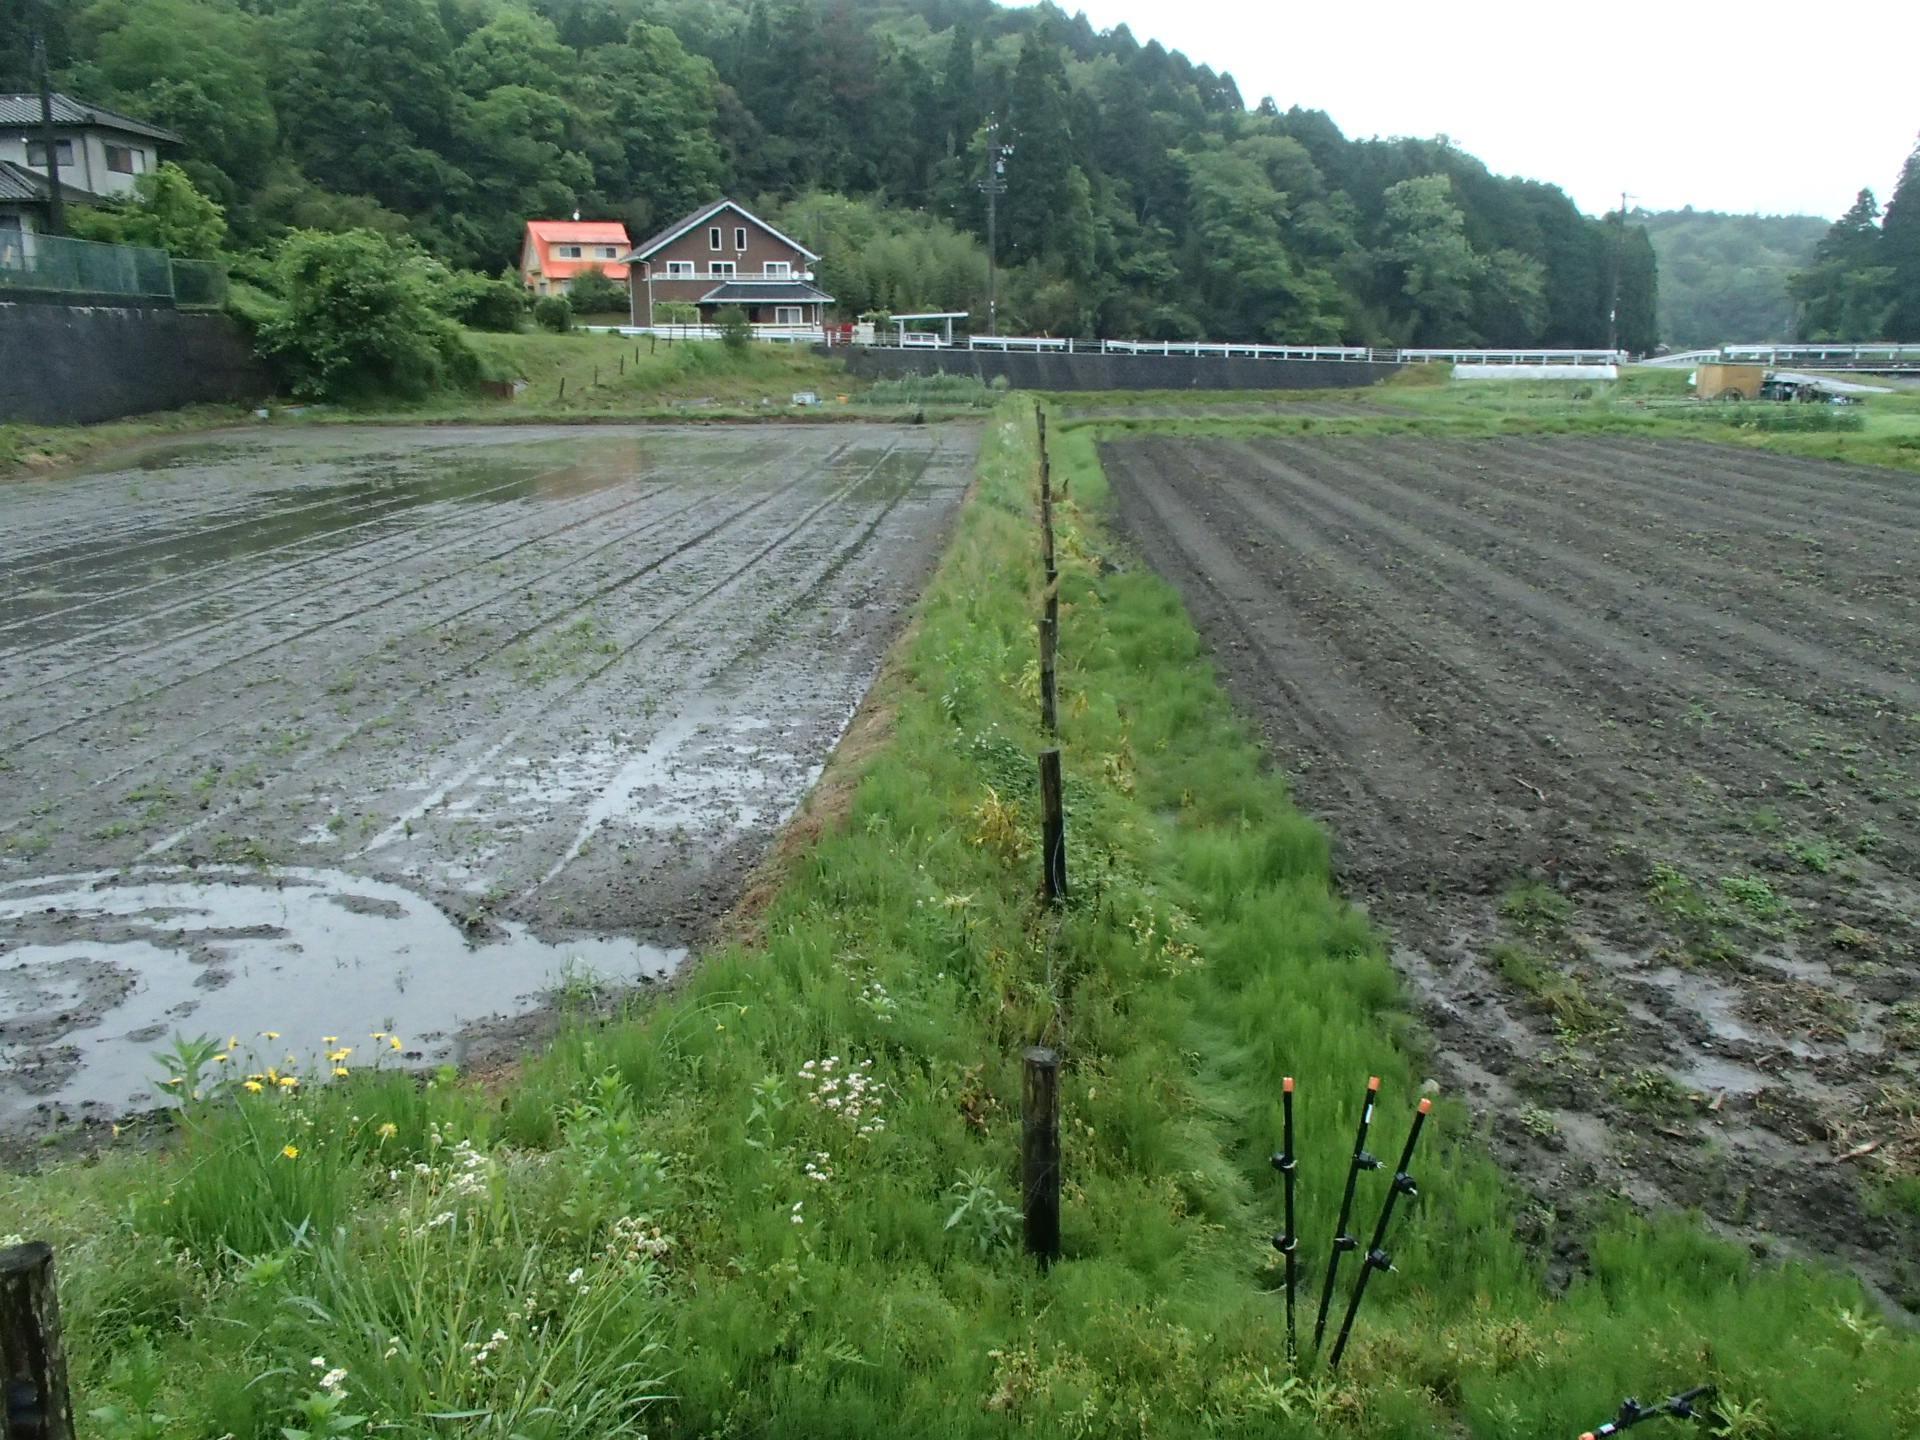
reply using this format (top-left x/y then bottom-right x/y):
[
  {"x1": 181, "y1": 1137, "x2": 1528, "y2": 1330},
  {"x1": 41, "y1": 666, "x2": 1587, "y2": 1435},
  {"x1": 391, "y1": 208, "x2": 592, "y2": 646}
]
[{"x1": 620, "y1": 200, "x2": 833, "y2": 330}]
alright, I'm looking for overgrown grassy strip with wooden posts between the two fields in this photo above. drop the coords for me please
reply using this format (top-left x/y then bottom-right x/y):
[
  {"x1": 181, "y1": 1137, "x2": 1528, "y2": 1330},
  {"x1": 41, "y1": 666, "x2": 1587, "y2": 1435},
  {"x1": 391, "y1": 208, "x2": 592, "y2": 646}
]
[{"x1": 0, "y1": 399, "x2": 1920, "y2": 1440}]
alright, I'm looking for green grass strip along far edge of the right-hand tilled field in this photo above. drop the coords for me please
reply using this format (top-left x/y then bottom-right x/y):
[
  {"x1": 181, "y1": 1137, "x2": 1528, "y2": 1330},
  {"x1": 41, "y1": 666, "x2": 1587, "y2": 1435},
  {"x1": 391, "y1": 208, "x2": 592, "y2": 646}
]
[{"x1": 1054, "y1": 365, "x2": 1920, "y2": 470}]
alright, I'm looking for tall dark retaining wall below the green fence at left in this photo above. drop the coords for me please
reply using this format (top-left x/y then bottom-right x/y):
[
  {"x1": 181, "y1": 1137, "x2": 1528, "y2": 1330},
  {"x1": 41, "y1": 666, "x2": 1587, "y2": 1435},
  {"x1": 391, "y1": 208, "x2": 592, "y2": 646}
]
[{"x1": 0, "y1": 300, "x2": 273, "y2": 424}]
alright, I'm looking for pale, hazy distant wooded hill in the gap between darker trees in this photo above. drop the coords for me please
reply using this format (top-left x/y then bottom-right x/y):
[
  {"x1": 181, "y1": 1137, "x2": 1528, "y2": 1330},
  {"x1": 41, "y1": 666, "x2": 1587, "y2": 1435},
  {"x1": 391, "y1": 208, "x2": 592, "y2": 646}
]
[{"x1": 1634, "y1": 205, "x2": 1828, "y2": 349}]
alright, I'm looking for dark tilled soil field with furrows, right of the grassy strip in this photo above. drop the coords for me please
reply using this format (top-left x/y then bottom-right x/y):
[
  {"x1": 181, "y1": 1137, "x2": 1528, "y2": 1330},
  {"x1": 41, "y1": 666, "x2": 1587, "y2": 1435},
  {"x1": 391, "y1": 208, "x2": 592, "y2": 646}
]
[{"x1": 1102, "y1": 438, "x2": 1920, "y2": 1309}]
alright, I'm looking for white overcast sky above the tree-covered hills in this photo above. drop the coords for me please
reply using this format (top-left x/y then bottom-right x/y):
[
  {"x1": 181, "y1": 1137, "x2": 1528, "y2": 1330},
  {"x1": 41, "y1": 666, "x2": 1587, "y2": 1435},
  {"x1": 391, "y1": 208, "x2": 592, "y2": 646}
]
[{"x1": 1029, "y1": 0, "x2": 1920, "y2": 217}]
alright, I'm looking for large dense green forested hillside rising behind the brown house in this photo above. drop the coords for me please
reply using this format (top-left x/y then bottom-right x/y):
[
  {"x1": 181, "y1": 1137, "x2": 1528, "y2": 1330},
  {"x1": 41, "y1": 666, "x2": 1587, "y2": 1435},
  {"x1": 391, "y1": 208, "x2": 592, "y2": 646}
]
[{"x1": 0, "y1": 0, "x2": 1657, "y2": 349}]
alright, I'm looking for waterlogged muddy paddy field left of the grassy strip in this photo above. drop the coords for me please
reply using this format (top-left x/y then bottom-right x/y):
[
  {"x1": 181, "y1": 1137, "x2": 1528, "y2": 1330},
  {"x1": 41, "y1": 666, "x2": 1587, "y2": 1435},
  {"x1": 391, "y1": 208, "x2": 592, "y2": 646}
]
[{"x1": 0, "y1": 424, "x2": 977, "y2": 1121}]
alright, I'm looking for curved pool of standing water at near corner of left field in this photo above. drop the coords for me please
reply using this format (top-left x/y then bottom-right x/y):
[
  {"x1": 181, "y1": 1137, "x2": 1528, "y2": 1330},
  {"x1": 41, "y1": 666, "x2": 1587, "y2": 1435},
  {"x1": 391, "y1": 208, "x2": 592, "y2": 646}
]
[{"x1": 0, "y1": 866, "x2": 685, "y2": 1114}]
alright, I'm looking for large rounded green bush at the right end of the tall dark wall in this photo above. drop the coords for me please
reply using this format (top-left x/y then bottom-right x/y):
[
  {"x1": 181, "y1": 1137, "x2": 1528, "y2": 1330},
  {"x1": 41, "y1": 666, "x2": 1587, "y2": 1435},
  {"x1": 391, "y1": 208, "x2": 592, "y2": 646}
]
[{"x1": 259, "y1": 230, "x2": 480, "y2": 399}]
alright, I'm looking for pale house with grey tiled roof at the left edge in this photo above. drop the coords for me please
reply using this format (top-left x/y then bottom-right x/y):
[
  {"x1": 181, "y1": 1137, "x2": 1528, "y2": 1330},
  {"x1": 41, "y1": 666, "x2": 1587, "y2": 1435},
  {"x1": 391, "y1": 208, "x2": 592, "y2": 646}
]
[{"x1": 0, "y1": 92, "x2": 180, "y2": 230}]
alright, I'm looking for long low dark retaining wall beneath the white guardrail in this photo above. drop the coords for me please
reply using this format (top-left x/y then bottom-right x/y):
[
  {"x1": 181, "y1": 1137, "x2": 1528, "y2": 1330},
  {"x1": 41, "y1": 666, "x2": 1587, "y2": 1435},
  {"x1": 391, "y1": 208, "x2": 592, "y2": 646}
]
[{"x1": 822, "y1": 346, "x2": 1400, "y2": 390}]
